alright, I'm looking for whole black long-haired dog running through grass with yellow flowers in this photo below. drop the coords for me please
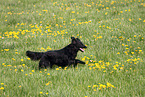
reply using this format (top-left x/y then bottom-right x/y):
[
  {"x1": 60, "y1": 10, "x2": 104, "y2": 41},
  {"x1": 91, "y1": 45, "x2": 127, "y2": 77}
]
[{"x1": 26, "y1": 37, "x2": 87, "y2": 69}]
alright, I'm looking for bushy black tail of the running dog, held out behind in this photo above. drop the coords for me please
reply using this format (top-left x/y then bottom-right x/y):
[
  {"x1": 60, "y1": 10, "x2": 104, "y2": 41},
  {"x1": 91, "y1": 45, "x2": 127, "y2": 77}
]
[{"x1": 26, "y1": 51, "x2": 44, "y2": 61}]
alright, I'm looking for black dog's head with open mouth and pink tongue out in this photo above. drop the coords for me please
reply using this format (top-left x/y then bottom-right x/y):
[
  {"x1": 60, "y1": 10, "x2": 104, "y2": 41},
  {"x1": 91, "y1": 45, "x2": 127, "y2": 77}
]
[{"x1": 71, "y1": 37, "x2": 87, "y2": 52}]
